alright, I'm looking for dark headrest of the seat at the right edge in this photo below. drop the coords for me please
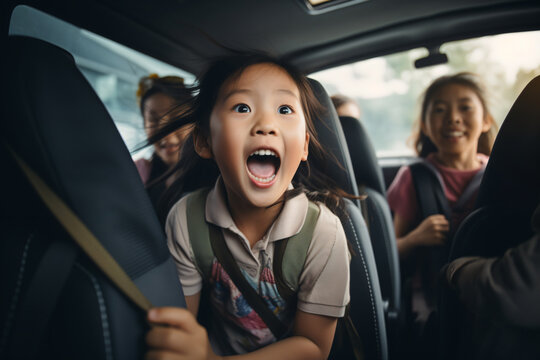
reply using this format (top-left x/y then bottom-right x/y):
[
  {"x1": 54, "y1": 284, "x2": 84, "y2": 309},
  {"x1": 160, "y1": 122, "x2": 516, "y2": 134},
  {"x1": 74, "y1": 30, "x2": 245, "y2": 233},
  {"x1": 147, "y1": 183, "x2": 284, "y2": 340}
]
[{"x1": 477, "y1": 76, "x2": 540, "y2": 216}]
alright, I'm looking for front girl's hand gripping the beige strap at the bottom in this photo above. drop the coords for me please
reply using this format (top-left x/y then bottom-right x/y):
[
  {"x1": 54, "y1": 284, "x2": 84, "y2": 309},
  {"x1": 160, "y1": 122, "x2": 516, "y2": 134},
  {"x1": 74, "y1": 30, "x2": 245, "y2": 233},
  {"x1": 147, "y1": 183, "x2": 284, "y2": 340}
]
[{"x1": 145, "y1": 307, "x2": 217, "y2": 360}]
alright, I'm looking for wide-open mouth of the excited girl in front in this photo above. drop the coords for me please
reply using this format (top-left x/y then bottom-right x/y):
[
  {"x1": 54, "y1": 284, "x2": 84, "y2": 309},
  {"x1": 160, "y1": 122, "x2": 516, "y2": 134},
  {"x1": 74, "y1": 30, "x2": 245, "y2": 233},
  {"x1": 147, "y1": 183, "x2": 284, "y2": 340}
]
[{"x1": 246, "y1": 149, "x2": 281, "y2": 187}]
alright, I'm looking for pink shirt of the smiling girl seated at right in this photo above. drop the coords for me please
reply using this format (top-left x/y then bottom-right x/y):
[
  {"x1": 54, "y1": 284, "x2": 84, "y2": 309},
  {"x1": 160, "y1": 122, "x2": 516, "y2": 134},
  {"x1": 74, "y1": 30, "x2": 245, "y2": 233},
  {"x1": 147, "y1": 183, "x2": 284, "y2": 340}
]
[{"x1": 388, "y1": 153, "x2": 488, "y2": 226}]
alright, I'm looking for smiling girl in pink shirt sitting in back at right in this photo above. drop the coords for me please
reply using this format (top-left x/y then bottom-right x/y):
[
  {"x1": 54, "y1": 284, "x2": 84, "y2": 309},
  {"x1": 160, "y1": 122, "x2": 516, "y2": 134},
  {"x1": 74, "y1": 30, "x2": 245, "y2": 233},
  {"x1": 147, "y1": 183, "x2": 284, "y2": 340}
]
[{"x1": 388, "y1": 73, "x2": 496, "y2": 334}]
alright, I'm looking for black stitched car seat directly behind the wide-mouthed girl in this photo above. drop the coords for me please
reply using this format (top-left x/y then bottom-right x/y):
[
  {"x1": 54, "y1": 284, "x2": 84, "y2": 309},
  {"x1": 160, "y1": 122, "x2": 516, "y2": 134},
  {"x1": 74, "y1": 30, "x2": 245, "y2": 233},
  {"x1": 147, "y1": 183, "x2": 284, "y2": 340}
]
[{"x1": 309, "y1": 79, "x2": 388, "y2": 359}]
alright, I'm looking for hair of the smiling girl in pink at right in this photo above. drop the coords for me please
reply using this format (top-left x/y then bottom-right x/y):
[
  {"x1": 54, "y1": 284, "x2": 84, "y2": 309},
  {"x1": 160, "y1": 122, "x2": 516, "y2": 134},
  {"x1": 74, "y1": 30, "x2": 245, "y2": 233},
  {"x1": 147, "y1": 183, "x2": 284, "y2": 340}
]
[{"x1": 412, "y1": 72, "x2": 497, "y2": 158}]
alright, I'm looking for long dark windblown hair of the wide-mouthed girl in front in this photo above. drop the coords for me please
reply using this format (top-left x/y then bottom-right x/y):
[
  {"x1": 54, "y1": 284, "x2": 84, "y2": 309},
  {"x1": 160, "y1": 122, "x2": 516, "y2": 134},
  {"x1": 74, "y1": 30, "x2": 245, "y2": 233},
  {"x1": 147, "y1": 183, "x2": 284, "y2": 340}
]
[{"x1": 148, "y1": 53, "x2": 355, "y2": 220}]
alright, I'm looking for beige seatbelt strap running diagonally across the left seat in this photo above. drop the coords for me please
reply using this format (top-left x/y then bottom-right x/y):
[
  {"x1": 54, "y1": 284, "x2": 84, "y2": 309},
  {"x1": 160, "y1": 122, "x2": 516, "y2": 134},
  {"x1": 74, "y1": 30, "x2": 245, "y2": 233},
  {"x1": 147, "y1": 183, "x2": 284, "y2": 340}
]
[{"x1": 6, "y1": 144, "x2": 152, "y2": 311}]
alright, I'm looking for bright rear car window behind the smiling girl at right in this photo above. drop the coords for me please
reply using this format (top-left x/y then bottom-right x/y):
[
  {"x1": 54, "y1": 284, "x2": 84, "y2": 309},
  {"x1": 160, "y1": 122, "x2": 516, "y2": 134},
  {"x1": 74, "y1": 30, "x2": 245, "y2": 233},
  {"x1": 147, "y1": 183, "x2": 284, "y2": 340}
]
[{"x1": 310, "y1": 31, "x2": 540, "y2": 157}]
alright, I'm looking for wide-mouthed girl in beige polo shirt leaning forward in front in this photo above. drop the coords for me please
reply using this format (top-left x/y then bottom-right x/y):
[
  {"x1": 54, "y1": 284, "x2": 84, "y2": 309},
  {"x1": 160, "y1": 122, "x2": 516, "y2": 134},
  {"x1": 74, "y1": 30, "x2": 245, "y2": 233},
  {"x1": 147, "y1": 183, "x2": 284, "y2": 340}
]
[{"x1": 147, "y1": 55, "x2": 349, "y2": 359}]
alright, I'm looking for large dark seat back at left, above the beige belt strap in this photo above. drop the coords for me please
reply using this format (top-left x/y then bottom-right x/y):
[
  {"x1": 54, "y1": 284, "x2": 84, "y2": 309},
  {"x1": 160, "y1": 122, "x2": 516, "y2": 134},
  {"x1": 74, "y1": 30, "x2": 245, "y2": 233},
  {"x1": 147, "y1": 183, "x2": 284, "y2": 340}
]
[{"x1": 0, "y1": 36, "x2": 181, "y2": 304}]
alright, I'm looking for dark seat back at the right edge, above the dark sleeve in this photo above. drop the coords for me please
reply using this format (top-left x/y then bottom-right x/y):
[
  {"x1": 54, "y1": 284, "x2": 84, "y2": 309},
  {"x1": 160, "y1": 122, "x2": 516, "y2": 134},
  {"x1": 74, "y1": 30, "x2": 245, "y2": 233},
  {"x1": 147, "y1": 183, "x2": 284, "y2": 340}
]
[{"x1": 450, "y1": 76, "x2": 540, "y2": 259}]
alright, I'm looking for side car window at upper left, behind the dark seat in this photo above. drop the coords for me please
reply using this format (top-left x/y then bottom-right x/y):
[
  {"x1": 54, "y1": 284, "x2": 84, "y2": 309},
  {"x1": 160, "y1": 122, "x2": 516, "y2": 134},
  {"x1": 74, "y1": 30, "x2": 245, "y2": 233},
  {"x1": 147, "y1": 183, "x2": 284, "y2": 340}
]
[{"x1": 9, "y1": 5, "x2": 195, "y2": 158}]
